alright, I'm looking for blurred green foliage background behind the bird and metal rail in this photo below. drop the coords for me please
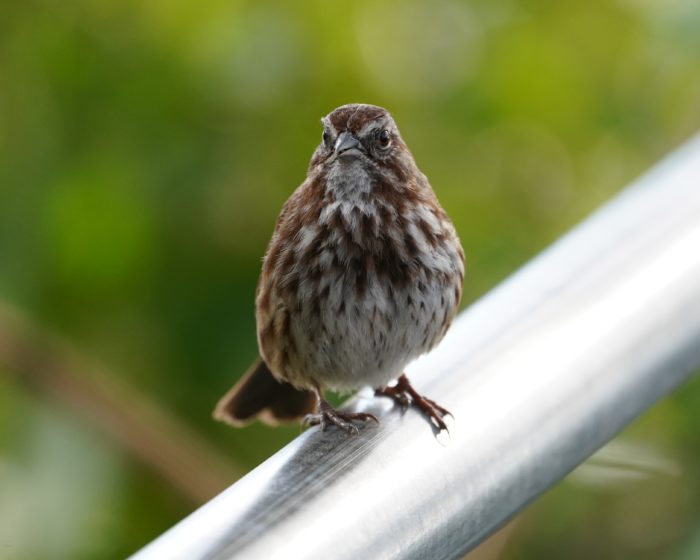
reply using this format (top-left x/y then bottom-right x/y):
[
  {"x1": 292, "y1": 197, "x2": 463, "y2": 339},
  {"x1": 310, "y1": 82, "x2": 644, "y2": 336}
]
[{"x1": 0, "y1": 0, "x2": 700, "y2": 560}]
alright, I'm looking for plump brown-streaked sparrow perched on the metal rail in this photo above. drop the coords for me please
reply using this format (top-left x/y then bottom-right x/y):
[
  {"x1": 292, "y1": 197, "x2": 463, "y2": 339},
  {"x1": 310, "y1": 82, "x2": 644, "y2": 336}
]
[{"x1": 214, "y1": 104, "x2": 464, "y2": 431}]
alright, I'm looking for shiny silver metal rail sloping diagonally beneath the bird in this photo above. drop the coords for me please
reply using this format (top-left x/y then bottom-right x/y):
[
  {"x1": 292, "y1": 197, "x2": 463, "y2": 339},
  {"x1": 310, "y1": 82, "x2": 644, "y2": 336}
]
[{"x1": 134, "y1": 137, "x2": 700, "y2": 560}]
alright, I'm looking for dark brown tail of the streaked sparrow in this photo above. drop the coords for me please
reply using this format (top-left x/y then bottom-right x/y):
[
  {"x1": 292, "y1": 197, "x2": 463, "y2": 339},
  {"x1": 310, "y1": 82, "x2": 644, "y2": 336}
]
[{"x1": 214, "y1": 358, "x2": 316, "y2": 426}]
